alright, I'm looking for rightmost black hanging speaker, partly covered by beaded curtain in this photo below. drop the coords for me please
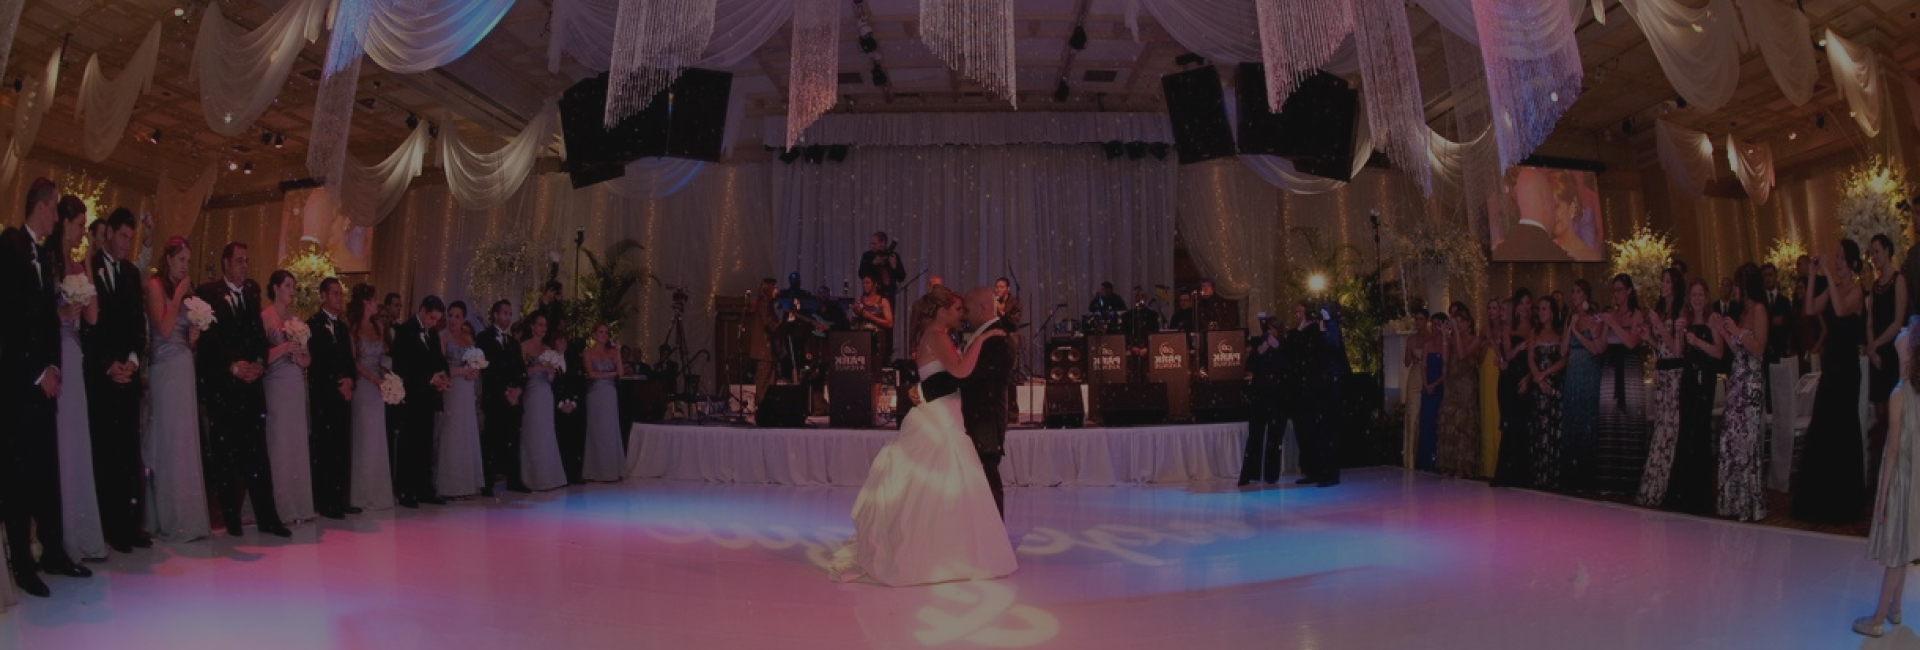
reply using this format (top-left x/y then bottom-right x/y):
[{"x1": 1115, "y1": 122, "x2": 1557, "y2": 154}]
[{"x1": 1235, "y1": 63, "x2": 1373, "y2": 180}]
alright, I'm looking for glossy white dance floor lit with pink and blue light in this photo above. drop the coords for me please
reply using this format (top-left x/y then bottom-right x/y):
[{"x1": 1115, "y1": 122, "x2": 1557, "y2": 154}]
[{"x1": 0, "y1": 468, "x2": 1889, "y2": 650}]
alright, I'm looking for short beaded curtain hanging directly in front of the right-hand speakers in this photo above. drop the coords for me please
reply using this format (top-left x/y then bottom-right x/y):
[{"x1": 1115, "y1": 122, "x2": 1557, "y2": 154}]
[{"x1": 1254, "y1": 0, "x2": 1359, "y2": 113}]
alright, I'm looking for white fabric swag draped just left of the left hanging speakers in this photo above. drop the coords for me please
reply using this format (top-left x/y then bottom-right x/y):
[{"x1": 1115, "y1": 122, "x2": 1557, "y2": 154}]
[{"x1": 440, "y1": 100, "x2": 561, "y2": 209}]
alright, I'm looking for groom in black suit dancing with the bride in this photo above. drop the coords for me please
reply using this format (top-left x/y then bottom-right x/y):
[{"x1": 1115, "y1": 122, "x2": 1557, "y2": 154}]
[{"x1": 960, "y1": 288, "x2": 1014, "y2": 520}]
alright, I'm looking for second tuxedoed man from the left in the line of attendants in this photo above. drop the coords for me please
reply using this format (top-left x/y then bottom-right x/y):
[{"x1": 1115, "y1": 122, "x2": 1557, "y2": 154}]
[{"x1": 81, "y1": 207, "x2": 154, "y2": 552}]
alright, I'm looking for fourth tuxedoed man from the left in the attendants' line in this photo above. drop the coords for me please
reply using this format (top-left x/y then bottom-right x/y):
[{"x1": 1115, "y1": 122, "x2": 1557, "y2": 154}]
[{"x1": 305, "y1": 278, "x2": 361, "y2": 520}]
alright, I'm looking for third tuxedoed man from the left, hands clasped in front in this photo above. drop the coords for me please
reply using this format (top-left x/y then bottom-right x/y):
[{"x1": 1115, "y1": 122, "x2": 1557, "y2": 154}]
[{"x1": 194, "y1": 242, "x2": 294, "y2": 537}]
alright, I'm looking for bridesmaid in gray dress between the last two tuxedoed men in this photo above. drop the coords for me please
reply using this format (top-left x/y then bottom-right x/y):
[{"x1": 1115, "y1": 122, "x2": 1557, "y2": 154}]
[{"x1": 434, "y1": 301, "x2": 486, "y2": 497}]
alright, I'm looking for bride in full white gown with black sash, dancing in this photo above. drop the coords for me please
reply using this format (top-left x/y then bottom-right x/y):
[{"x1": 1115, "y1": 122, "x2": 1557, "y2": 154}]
[{"x1": 829, "y1": 288, "x2": 1018, "y2": 587}]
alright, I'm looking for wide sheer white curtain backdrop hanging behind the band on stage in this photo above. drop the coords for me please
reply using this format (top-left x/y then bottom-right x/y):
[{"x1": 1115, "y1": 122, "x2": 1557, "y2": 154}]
[{"x1": 771, "y1": 144, "x2": 1177, "y2": 366}]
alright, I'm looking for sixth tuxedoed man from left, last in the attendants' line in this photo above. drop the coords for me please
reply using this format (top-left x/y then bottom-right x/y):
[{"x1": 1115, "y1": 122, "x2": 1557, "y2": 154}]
[{"x1": 474, "y1": 301, "x2": 526, "y2": 497}]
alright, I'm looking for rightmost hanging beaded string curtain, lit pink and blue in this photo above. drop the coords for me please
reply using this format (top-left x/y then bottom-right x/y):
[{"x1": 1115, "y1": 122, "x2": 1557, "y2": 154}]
[{"x1": 1473, "y1": 0, "x2": 1582, "y2": 173}]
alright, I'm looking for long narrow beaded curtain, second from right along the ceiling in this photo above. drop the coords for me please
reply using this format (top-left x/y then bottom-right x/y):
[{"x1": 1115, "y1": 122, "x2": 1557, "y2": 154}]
[{"x1": 1352, "y1": 0, "x2": 1434, "y2": 196}]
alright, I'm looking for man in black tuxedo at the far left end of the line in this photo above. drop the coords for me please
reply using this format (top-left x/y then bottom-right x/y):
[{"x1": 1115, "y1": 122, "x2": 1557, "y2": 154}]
[{"x1": 0, "y1": 178, "x2": 92, "y2": 598}]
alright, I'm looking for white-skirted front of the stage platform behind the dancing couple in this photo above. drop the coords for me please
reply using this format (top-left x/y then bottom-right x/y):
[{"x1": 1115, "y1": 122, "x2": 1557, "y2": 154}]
[{"x1": 626, "y1": 422, "x2": 1246, "y2": 487}]
